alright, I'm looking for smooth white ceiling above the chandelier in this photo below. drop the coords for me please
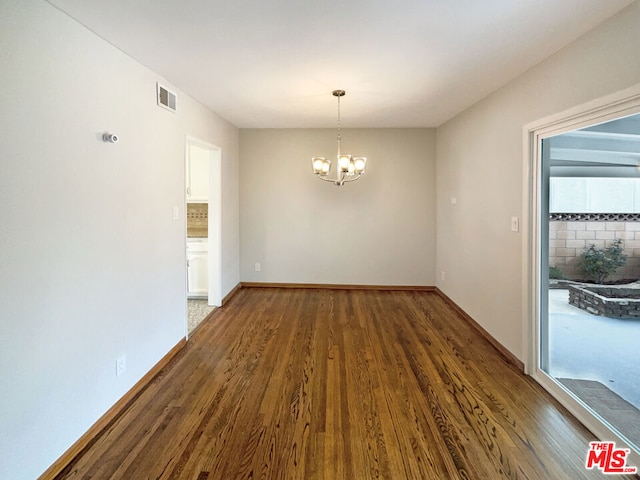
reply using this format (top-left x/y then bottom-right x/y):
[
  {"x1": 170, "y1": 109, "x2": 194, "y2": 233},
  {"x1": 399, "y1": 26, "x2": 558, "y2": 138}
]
[{"x1": 49, "y1": 0, "x2": 633, "y2": 128}]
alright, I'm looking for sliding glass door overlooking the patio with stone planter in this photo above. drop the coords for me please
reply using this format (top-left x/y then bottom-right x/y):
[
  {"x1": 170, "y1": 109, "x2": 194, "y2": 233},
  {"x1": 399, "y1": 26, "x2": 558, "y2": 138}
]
[{"x1": 533, "y1": 109, "x2": 640, "y2": 459}]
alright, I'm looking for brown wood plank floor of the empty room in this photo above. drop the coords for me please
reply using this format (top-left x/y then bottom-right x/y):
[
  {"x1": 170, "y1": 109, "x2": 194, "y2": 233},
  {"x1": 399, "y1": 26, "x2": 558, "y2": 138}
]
[{"x1": 58, "y1": 288, "x2": 633, "y2": 480}]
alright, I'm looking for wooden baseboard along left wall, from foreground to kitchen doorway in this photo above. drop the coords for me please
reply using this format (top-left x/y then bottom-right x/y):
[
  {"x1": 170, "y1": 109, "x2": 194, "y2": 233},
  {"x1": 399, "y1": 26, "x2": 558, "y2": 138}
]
[{"x1": 38, "y1": 338, "x2": 187, "y2": 480}]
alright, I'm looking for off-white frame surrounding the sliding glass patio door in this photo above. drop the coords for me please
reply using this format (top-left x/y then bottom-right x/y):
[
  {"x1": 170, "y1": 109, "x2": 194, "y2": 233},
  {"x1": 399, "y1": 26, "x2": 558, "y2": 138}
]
[{"x1": 522, "y1": 84, "x2": 640, "y2": 467}]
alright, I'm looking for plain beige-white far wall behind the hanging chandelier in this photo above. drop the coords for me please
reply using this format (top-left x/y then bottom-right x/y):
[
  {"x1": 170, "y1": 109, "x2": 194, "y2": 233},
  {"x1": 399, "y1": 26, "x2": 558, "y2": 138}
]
[{"x1": 240, "y1": 129, "x2": 435, "y2": 285}]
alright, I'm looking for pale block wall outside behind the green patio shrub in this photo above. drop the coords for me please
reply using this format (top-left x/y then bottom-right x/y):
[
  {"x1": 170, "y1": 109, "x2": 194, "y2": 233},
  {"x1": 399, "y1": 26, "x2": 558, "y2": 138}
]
[{"x1": 549, "y1": 214, "x2": 640, "y2": 281}]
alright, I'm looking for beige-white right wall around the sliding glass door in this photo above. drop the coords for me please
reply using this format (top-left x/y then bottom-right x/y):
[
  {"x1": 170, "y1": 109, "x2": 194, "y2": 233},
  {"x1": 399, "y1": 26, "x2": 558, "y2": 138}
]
[{"x1": 436, "y1": 2, "x2": 640, "y2": 360}]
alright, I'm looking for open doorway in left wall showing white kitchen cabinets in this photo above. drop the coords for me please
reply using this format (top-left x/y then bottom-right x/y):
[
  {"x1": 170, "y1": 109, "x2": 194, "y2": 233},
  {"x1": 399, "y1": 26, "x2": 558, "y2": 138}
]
[{"x1": 185, "y1": 137, "x2": 222, "y2": 333}]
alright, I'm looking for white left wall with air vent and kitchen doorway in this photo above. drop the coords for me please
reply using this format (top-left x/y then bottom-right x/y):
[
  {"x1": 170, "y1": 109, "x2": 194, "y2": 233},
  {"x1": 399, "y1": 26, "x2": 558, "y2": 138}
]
[{"x1": 0, "y1": 0, "x2": 239, "y2": 480}]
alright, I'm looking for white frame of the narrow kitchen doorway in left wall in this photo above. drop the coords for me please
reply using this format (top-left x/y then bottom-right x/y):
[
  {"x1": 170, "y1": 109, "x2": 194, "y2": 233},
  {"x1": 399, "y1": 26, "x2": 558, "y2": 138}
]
[{"x1": 183, "y1": 135, "x2": 222, "y2": 307}]
